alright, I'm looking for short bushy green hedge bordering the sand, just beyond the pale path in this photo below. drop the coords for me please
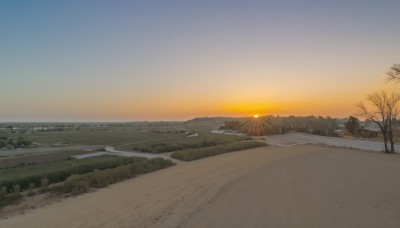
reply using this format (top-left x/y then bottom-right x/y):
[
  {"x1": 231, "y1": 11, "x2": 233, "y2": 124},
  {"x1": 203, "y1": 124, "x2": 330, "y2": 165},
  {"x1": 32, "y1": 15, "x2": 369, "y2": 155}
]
[{"x1": 171, "y1": 141, "x2": 267, "y2": 161}]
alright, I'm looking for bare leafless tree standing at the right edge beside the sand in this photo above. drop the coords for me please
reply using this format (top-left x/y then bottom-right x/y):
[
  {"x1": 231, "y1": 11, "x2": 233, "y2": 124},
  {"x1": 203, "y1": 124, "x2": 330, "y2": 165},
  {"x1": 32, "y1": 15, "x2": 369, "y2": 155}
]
[{"x1": 357, "y1": 90, "x2": 400, "y2": 153}]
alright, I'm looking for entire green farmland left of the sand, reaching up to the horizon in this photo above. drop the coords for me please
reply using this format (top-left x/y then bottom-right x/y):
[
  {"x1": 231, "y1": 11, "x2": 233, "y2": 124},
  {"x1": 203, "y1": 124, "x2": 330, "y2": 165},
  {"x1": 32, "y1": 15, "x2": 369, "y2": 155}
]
[{"x1": 0, "y1": 118, "x2": 258, "y2": 207}]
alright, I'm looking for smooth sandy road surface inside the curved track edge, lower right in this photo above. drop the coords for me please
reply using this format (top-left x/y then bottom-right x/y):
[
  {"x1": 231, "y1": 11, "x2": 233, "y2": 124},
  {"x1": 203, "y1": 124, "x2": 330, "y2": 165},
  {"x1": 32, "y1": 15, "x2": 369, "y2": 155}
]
[{"x1": 184, "y1": 148, "x2": 400, "y2": 228}]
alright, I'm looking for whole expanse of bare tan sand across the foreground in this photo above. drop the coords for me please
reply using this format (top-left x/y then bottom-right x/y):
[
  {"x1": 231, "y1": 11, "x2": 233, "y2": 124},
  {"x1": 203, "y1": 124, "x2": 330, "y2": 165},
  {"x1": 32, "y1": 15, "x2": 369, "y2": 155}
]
[{"x1": 0, "y1": 145, "x2": 400, "y2": 228}]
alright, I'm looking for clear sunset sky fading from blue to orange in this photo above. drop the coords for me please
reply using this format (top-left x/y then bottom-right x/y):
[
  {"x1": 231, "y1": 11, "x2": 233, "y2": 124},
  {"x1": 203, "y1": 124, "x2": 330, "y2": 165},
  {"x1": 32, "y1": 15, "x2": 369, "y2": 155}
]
[{"x1": 0, "y1": 0, "x2": 400, "y2": 121}]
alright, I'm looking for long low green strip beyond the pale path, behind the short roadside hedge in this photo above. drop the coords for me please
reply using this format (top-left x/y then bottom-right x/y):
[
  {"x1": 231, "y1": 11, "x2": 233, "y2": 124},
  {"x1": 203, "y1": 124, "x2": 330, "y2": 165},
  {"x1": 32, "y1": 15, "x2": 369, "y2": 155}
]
[{"x1": 118, "y1": 133, "x2": 248, "y2": 153}]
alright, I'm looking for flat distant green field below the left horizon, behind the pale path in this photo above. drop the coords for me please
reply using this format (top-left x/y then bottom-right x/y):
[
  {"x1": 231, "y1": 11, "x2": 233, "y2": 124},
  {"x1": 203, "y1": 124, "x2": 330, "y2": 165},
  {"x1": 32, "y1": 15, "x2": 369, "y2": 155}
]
[{"x1": 0, "y1": 120, "x2": 230, "y2": 149}]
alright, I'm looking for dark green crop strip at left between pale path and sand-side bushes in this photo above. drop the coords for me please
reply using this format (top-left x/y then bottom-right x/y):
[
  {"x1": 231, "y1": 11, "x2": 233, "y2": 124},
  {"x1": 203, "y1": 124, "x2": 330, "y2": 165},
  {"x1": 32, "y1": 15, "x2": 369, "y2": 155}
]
[{"x1": 0, "y1": 156, "x2": 145, "y2": 192}]
